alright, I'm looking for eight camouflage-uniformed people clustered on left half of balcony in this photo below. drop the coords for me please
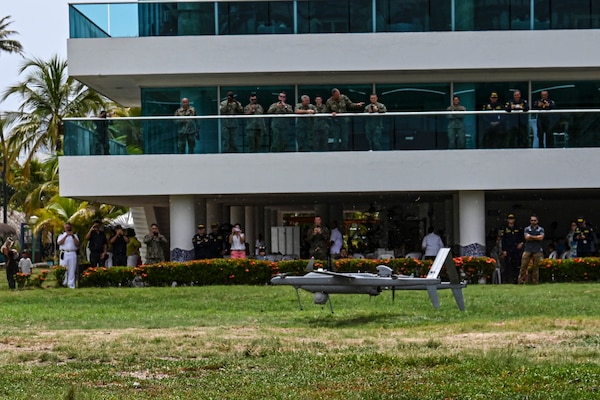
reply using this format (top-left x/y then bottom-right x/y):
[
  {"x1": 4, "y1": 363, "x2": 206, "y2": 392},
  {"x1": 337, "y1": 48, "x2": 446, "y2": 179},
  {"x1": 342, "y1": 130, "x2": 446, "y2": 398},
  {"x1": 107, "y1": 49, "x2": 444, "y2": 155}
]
[{"x1": 175, "y1": 88, "x2": 387, "y2": 154}]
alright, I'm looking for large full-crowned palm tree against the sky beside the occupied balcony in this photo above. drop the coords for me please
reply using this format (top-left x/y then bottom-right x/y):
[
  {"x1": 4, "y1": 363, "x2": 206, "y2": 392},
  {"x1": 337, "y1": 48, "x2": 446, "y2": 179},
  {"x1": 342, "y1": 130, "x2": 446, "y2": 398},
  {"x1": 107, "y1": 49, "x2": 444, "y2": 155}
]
[{"x1": 2, "y1": 56, "x2": 104, "y2": 172}]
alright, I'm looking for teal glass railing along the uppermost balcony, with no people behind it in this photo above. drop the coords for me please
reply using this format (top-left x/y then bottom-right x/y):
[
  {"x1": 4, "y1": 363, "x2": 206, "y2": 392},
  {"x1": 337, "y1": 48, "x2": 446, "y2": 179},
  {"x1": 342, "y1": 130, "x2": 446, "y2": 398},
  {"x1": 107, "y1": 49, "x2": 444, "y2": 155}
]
[{"x1": 69, "y1": 0, "x2": 600, "y2": 38}]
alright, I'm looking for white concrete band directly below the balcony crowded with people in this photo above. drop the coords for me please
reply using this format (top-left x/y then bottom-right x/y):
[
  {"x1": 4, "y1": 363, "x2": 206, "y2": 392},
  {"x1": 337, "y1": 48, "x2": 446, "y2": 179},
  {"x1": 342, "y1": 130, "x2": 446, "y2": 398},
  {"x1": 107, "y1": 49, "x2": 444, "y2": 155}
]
[{"x1": 59, "y1": 148, "x2": 600, "y2": 198}]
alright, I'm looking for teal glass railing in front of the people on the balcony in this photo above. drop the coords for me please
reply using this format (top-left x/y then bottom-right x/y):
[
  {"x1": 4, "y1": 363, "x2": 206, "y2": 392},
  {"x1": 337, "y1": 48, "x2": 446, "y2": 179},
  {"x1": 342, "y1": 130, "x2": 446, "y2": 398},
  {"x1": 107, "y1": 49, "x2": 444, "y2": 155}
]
[{"x1": 64, "y1": 110, "x2": 600, "y2": 156}]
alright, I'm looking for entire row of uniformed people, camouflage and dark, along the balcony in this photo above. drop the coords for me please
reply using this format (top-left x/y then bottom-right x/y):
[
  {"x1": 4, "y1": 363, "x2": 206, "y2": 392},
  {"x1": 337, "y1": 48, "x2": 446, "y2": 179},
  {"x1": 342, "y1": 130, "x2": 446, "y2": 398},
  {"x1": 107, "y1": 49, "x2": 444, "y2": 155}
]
[{"x1": 171, "y1": 88, "x2": 556, "y2": 154}]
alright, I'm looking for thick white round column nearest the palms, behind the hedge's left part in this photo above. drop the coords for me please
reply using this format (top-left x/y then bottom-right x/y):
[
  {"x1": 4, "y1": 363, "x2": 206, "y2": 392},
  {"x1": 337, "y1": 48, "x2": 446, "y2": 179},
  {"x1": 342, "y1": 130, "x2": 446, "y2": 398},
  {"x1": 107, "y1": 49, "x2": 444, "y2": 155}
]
[{"x1": 169, "y1": 195, "x2": 196, "y2": 261}]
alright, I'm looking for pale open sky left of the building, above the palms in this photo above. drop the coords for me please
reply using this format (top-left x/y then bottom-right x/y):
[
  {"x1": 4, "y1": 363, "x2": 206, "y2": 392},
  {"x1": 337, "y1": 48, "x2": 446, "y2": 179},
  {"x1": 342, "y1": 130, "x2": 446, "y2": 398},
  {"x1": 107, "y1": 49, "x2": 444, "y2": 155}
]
[{"x1": 0, "y1": 0, "x2": 97, "y2": 111}]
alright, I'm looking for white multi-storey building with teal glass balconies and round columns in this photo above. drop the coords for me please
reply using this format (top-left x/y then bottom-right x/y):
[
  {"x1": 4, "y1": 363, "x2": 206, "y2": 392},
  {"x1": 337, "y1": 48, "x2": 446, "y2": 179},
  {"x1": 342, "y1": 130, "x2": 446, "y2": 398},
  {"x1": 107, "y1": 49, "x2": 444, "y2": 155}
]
[{"x1": 60, "y1": 0, "x2": 600, "y2": 259}]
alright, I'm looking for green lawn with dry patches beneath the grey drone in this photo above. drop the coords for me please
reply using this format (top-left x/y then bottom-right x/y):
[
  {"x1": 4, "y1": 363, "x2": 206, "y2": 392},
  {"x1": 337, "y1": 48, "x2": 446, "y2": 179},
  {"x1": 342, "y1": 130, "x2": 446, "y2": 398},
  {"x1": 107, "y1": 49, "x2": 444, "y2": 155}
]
[{"x1": 0, "y1": 271, "x2": 600, "y2": 400}]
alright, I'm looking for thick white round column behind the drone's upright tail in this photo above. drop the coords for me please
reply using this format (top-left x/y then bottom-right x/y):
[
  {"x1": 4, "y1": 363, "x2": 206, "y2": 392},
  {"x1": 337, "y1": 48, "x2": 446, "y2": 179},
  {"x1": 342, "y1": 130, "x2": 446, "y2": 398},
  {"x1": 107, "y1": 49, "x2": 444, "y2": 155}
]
[{"x1": 458, "y1": 191, "x2": 485, "y2": 257}]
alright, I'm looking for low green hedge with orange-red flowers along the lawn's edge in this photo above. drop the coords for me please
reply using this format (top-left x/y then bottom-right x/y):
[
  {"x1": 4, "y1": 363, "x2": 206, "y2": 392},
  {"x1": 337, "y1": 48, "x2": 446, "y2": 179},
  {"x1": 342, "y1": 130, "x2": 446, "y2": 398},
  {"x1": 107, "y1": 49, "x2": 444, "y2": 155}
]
[{"x1": 54, "y1": 257, "x2": 600, "y2": 287}]
